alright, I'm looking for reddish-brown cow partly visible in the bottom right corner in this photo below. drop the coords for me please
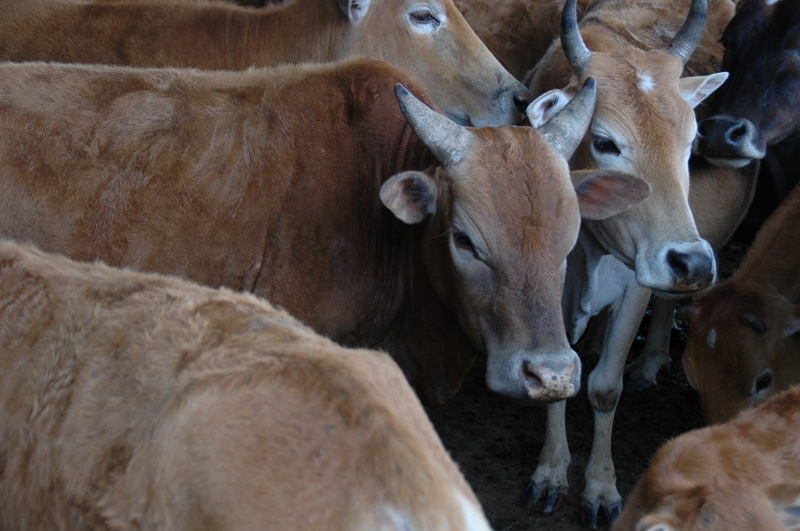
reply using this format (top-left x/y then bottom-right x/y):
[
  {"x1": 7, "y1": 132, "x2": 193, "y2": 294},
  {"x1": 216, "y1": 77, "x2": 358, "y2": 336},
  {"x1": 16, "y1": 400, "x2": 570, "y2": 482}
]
[{"x1": 613, "y1": 386, "x2": 800, "y2": 531}]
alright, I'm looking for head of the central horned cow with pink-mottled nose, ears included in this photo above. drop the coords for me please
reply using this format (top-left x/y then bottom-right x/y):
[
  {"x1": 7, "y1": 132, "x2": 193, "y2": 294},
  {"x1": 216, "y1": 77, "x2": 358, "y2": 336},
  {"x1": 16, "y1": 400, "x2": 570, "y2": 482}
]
[{"x1": 381, "y1": 80, "x2": 648, "y2": 400}]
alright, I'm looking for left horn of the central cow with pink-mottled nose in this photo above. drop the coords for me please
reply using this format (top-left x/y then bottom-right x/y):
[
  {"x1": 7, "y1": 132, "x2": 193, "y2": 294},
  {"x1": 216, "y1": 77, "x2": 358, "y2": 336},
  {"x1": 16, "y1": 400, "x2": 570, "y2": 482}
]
[{"x1": 394, "y1": 83, "x2": 472, "y2": 169}]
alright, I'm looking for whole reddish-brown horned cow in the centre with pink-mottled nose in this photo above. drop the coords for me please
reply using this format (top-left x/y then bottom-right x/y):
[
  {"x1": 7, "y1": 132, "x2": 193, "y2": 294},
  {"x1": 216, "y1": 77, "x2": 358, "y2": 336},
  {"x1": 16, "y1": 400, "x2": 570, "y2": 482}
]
[{"x1": 0, "y1": 59, "x2": 649, "y2": 403}]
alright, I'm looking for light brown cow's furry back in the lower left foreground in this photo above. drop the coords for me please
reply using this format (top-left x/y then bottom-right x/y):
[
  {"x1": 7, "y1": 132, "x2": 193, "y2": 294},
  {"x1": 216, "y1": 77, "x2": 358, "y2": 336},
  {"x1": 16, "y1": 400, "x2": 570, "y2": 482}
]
[{"x1": 0, "y1": 241, "x2": 489, "y2": 531}]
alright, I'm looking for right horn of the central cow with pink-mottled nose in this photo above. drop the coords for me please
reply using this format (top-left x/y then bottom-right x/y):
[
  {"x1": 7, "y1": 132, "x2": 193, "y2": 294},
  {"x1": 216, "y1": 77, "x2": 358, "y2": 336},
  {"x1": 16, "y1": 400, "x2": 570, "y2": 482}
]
[{"x1": 538, "y1": 77, "x2": 597, "y2": 160}]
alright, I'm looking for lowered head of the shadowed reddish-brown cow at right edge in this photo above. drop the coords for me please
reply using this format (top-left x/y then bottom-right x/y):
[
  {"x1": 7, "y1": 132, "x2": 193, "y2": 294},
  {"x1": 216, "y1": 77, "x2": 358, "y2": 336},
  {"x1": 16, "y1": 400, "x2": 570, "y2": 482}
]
[{"x1": 682, "y1": 282, "x2": 800, "y2": 423}]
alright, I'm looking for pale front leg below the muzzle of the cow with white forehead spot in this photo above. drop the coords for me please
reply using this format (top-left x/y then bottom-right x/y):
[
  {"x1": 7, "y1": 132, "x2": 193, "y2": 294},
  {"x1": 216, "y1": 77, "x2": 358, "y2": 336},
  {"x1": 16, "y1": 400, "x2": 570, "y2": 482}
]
[{"x1": 581, "y1": 282, "x2": 651, "y2": 529}]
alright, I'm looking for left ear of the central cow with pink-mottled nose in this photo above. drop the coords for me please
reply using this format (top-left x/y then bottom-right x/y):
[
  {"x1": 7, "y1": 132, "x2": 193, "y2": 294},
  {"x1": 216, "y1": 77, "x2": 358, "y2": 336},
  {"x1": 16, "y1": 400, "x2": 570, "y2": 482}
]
[{"x1": 380, "y1": 171, "x2": 438, "y2": 225}]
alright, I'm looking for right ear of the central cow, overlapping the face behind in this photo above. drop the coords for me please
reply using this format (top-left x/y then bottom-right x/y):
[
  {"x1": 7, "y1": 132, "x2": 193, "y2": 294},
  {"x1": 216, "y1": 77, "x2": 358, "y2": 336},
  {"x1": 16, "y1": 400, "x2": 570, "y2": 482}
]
[{"x1": 570, "y1": 170, "x2": 650, "y2": 219}]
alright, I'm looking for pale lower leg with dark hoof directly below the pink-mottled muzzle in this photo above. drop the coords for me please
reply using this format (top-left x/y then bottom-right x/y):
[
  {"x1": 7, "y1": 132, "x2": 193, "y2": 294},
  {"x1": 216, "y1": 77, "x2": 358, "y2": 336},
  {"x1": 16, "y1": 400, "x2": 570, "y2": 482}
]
[{"x1": 521, "y1": 400, "x2": 571, "y2": 514}]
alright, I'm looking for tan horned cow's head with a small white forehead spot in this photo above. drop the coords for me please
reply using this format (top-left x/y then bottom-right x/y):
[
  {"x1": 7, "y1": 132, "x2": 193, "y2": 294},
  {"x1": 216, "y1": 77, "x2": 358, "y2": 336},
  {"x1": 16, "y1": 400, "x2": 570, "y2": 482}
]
[{"x1": 532, "y1": 0, "x2": 725, "y2": 293}]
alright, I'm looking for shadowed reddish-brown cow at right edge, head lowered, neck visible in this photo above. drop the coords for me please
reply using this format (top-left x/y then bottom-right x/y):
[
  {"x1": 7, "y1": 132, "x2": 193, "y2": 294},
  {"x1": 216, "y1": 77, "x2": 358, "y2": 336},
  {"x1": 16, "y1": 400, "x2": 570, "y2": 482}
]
[{"x1": 682, "y1": 183, "x2": 800, "y2": 423}]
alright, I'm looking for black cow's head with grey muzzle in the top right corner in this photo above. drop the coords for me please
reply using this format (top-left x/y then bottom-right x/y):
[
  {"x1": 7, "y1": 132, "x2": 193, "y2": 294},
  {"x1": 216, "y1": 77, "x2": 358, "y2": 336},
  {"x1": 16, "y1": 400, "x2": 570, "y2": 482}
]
[{"x1": 695, "y1": 0, "x2": 800, "y2": 168}]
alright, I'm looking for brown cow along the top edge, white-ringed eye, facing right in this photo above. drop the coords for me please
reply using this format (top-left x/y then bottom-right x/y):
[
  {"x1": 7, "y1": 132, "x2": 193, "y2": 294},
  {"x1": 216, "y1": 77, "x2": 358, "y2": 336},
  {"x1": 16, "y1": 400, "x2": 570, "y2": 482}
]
[{"x1": 0, "y1": 0, "x2": 530, "y2": 126}]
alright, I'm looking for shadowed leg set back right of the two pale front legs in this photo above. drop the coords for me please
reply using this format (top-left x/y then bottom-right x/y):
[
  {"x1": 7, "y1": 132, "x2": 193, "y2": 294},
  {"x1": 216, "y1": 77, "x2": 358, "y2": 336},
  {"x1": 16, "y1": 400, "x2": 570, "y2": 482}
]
[{"x1": 625, "y1": 295, "x2": 677, "y2": 393}]
